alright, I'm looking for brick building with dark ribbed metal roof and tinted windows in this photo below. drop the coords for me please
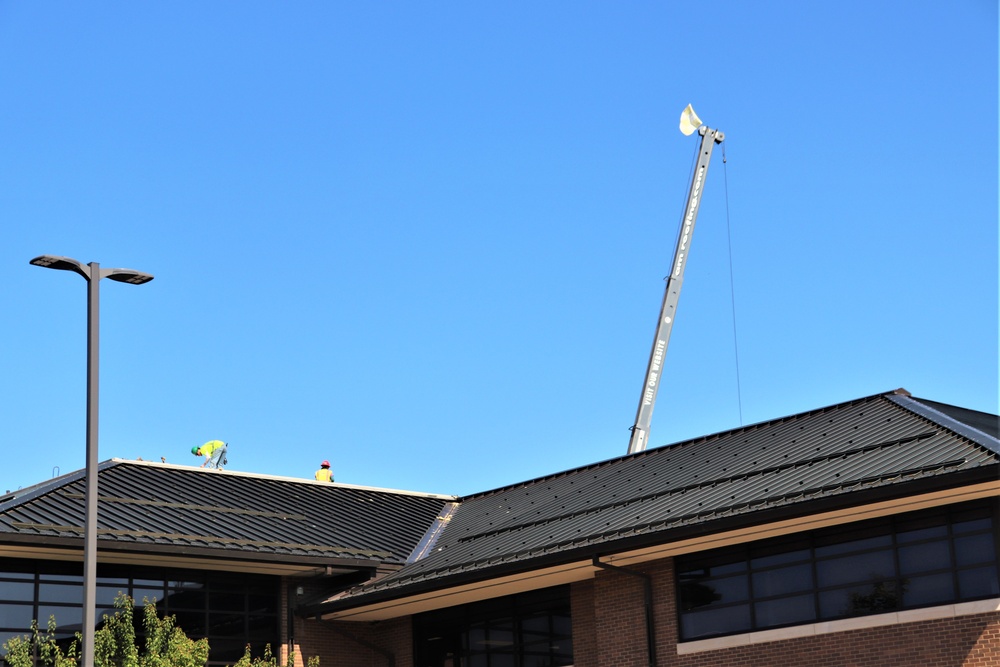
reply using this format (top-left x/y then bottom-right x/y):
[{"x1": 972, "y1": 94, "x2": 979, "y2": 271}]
[{"x1": 0, "y1": 390, "x2": 1000, "y2": 667}]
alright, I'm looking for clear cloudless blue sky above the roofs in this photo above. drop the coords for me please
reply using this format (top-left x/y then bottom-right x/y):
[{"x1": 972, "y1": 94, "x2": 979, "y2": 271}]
[{"x1": 0, "y1": 0, "x2": 998, "y2": 494}]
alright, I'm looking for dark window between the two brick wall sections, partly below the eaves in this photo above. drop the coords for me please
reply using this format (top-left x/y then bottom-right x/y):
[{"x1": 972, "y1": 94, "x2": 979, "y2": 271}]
[{"x1": 413, "y1": 586, "x2": 573, "y2": 667}]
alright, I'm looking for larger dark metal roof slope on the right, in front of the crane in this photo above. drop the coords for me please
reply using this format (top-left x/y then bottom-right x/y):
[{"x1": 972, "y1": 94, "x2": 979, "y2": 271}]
[{"x1": 325, "y1": 390, "x2": 1000, "y2": 610}]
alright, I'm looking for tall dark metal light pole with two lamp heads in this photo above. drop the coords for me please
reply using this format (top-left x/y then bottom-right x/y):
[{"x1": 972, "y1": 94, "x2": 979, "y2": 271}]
[{"x1": 31, "y1": 255, "x2": 153, "y2": 667}]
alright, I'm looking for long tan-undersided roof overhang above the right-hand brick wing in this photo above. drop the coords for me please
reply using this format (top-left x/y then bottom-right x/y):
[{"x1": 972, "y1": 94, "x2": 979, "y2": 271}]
[{"x1": 316, "y1": 474, "x2": 1000, "y2": 621}]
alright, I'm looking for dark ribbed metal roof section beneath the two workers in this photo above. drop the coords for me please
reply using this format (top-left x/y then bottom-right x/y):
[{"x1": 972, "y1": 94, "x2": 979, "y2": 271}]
[{"x1": 0, "y1": 460, "x2": 454, "y2": 566}]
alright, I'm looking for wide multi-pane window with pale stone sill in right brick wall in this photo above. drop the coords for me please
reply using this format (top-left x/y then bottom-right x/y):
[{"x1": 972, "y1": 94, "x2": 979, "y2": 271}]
[{"x1": 676, "y1": 502, "x2": 1000, "y2": 640}]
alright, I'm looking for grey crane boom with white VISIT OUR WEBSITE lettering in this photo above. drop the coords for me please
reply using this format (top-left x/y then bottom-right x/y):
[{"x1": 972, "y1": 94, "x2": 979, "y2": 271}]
[{"x1": 628, "y1": 118, "x2": 725, "y2": 454}]
